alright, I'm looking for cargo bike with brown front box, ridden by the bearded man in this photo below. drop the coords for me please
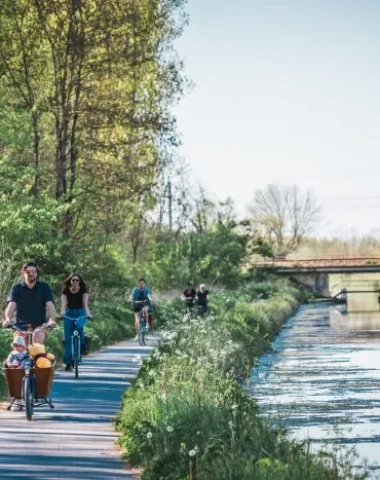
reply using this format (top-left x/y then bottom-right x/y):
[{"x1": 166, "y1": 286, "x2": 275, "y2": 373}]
[{"x1": 3, "y1": 324, "x2": 55, "y2": 420}]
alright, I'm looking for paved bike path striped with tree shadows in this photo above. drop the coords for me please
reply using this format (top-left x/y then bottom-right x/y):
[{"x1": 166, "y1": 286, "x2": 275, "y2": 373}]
[{"x1": 0, "y1": 339, "x2": 154, "y2": 480}]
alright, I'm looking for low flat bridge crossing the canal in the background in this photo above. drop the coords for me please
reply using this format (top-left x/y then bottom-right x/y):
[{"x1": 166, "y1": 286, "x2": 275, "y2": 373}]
[{"x1": 253, "y1": 257, "x2": 380, "y2": 297}]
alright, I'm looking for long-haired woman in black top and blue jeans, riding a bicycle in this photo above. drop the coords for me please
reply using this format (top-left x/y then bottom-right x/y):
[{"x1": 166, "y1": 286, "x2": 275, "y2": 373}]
[{"x1": 60, "y1": 272, "x2": 92, "y2": 372}]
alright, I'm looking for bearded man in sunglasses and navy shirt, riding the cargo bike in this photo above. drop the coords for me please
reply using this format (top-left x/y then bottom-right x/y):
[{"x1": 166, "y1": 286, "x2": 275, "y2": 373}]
[{"x1": 3, "y1": 262, "x2": 56, "y2": 343}]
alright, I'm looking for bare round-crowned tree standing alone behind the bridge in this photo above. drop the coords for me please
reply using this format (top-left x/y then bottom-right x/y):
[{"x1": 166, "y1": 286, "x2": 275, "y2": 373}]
[{"x1": 248, "y1": 184, "x2": 321, "y2": 257}]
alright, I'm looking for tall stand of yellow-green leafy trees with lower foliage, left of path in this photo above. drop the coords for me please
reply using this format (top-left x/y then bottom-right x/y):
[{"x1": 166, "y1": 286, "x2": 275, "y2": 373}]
[{"x1": 0, "y1": 0, "x2": 186, "y2": 284}]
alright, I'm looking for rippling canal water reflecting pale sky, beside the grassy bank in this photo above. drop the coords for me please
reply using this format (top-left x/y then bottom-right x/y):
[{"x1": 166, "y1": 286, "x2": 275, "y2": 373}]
[{"x1": 249, "y1": 293, "x2": 380, "y2": 479}]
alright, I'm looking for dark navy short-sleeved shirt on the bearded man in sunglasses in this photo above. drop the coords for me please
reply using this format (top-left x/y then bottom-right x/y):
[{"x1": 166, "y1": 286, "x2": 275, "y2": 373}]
[{"x1": 7, "y1": 281, "x2": 54, "y2": 328}]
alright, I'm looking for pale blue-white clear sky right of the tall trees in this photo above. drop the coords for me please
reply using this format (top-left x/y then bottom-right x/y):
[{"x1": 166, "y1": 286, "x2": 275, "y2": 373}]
[{"x1": 175, "y1": 0, "x2": 380, "y2": 237}]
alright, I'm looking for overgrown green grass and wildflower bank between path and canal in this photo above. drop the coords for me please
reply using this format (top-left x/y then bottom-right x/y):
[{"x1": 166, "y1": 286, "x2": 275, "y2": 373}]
[{"x1": 116, "y1": 280, "x2": 365, "y2": 480}]
